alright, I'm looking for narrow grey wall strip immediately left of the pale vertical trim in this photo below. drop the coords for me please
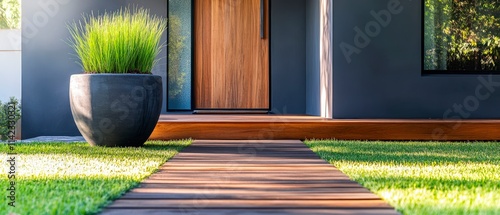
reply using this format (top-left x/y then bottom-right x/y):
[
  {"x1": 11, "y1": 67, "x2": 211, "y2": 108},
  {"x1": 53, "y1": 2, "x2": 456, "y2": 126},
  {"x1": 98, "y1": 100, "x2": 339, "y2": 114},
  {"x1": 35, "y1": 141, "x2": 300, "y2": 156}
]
[{"x1": 306, "y1": 0, "x2": 321, "y2": 115}]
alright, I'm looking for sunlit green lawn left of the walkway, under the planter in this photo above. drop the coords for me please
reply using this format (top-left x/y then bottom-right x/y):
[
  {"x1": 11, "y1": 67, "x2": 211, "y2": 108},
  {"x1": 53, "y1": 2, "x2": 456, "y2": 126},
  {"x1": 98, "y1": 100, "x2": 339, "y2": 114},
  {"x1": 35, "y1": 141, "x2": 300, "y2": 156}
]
[{"x1": 0, "y1": 140, "x2": 191, "y2": 214}]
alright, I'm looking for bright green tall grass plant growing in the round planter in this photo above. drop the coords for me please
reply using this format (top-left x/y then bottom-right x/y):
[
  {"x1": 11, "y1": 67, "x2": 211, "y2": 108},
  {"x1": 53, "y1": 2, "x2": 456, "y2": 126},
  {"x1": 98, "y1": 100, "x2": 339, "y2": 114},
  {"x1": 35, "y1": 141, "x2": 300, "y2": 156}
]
[{"x1": 68, "y1": 8, "x2": 167, "y2": 74}]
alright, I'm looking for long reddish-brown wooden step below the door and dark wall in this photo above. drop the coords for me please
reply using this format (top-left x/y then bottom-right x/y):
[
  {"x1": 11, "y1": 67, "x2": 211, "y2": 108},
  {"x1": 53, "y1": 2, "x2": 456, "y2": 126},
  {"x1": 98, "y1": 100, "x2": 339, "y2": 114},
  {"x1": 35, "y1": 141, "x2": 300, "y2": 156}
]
[{"x1": 150, "y1": 115, "x2": 500, "y2": 141}]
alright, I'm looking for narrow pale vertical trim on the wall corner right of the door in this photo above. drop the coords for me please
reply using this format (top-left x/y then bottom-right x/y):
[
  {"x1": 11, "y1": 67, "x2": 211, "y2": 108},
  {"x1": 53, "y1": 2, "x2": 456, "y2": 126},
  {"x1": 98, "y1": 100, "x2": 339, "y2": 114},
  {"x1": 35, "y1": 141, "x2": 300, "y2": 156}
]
[{"x1": 320, "y1": 0, "x2": 333, "y2": 118}]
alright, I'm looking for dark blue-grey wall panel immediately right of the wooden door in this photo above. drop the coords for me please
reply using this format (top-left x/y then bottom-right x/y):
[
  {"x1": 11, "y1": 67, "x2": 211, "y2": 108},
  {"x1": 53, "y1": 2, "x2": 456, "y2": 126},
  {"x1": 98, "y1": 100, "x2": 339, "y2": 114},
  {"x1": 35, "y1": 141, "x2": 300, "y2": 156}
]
[{"x1": 271, "y1": 0, "x2": 308, "y2": 114}]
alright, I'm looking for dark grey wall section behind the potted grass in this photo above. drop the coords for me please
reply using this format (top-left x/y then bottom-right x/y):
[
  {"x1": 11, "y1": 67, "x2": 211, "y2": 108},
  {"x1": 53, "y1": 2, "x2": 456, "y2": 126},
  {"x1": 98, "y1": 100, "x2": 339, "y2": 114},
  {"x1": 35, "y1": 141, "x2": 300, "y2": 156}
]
[{"x1": 22, "y1": 0, "x2": 167, "y2": 138}]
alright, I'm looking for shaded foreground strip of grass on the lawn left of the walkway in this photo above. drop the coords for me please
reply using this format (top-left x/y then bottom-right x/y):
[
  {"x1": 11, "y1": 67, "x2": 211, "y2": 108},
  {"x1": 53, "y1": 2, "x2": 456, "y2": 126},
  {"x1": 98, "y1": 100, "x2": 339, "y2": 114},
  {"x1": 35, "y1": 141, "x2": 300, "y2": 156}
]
[{"x1": 0, "y1": 177, "x2": 139, "y2": 214}]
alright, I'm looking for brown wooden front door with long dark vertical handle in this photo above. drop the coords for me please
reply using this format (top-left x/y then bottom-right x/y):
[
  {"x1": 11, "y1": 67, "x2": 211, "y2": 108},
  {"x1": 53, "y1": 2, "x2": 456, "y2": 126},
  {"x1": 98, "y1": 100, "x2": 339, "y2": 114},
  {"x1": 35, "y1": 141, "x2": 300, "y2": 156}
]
[{"x1": 194, "y1": 0, "x2": 269, "y2": 110}]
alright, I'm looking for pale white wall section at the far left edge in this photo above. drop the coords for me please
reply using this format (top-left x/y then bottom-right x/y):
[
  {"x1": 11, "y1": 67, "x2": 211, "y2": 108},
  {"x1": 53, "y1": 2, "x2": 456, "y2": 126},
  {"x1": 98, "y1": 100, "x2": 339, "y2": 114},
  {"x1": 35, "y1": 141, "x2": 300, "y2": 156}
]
[{"x1": 0, "y1": 29, "x2": 21, "y2": 102}]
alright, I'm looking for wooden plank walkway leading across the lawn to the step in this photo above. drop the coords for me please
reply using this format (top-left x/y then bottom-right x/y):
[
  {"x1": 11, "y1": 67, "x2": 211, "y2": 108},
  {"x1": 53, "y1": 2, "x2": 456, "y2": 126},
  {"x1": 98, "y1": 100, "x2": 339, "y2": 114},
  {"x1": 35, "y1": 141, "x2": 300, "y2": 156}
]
[{"x1": 102, "y1": 140, "x2": 398, "y2": 215}]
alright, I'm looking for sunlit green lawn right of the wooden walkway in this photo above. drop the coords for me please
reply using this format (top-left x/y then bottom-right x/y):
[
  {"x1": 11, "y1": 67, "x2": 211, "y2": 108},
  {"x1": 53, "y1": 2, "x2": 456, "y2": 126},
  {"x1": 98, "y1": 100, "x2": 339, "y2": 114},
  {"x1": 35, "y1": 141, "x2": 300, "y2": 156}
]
[{"x1": 306, "y1": 140, "x2": 500, "y2": 215}]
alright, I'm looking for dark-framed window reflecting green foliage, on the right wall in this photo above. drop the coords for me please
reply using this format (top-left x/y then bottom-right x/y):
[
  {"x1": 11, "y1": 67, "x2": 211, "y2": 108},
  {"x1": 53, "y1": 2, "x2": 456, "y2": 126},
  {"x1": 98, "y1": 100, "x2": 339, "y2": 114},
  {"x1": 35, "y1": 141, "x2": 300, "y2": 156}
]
[{"x1": 423, "y1": 0, "x2": 500, "y2": 74}]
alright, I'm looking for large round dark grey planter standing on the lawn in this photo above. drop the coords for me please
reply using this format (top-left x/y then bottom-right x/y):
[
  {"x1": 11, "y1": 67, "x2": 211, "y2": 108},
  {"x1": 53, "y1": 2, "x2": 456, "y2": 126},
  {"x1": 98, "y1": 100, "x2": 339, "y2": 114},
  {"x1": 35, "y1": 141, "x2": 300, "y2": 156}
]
[{"x1": 69, "y1": 74, "x2": 163, "y2": 147}]
